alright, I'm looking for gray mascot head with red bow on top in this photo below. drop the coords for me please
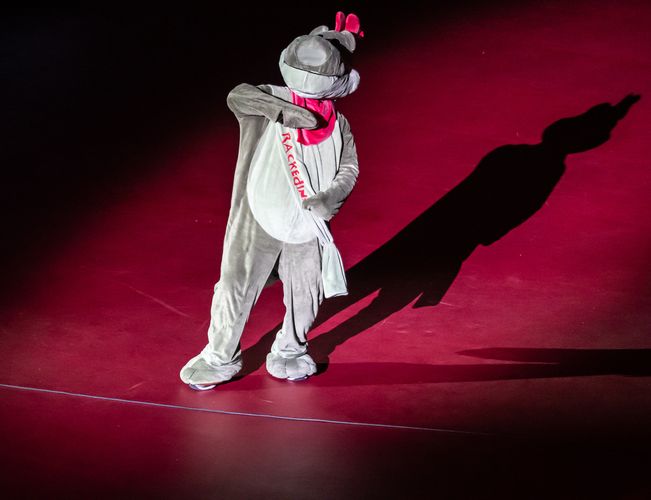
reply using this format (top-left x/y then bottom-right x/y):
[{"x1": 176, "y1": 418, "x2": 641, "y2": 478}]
[{"x1": 280, "y1": 12, "x2": 364, "y2": 99}]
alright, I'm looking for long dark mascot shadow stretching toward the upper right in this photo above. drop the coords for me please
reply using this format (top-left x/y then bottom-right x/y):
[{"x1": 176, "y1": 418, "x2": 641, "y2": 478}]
[{"x1": 243, "y1": 94, "x2": 650, "y2": 383}]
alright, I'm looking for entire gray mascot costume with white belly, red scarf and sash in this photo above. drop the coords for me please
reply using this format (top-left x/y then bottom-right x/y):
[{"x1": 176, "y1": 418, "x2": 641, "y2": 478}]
[{"x1": 180, "y1": 12, "x2": 363, "y2": 390}]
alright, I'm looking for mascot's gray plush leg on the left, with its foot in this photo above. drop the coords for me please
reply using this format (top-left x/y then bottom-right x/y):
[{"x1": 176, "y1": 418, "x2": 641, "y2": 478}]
[{"x1": 180, "y1": 207, "x2": 282, "y2": 385}]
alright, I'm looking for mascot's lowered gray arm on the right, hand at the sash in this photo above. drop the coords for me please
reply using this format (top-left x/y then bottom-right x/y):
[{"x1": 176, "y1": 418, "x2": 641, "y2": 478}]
[{"x1": 303, "y1": 115, "x2": 359, "y2": 220}]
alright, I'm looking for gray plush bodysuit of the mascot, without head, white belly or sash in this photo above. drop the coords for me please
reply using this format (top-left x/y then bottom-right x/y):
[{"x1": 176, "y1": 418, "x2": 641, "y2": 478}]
[{"x1": 181, "y1": 84, "x2": 358, "y2": 384}]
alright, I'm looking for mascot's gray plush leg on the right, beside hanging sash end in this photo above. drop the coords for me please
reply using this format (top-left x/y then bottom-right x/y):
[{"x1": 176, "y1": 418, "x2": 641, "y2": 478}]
[{"x1": 267, "y1": 239, "x2": 323, "y2": 380}]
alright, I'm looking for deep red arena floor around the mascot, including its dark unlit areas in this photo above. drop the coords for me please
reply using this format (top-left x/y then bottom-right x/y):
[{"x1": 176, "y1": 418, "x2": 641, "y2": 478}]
[{"x1": 0, "y1": 0, "x2": 651, "y2": 499}]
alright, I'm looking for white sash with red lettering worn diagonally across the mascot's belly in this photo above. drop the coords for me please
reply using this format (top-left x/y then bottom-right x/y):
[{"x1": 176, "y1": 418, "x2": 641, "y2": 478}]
[{"x1": 270, "y1": 123, "x2": 348, "y2": 298}]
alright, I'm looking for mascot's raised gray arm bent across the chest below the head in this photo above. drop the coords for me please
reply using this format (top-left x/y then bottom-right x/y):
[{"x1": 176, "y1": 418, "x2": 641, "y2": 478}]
[{"x1": 226, "y1": 83, "x2": 318, "y2": 129}]
